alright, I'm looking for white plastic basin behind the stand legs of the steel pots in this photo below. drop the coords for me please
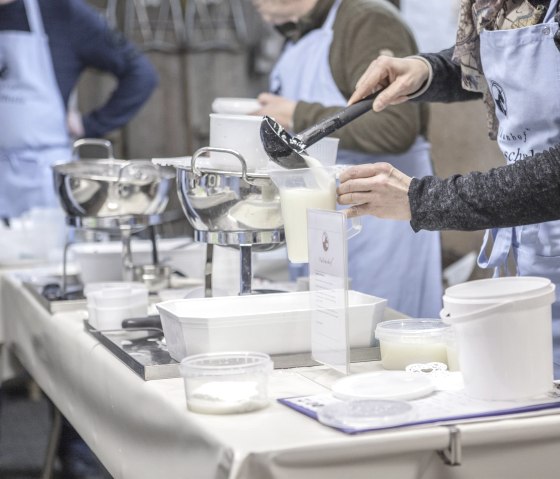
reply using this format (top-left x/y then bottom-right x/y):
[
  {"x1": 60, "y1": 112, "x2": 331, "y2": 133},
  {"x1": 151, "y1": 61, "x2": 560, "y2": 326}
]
[{"x1": 72, "y1": 238, "x2": 206, "y2": 284}]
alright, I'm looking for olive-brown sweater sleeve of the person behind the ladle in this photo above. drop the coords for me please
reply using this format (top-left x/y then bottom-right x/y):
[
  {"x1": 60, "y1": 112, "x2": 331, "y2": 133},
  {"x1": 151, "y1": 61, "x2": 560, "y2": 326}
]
[{"x1": 293, "y1": 0, "x2": 420, "y2": 153}]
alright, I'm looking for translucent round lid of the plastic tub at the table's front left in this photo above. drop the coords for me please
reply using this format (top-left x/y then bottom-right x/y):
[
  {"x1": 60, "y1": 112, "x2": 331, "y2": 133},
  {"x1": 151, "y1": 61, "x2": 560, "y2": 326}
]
[{"x1": 179, "y1": 351, "x2": 273, "y2": 377}]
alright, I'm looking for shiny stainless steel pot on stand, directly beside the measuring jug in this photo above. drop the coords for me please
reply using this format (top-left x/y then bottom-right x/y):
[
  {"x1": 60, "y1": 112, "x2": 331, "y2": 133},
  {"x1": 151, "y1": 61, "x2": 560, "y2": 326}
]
[{"x1": 177, "y1": 147, "x2": 284, "y2": 245}]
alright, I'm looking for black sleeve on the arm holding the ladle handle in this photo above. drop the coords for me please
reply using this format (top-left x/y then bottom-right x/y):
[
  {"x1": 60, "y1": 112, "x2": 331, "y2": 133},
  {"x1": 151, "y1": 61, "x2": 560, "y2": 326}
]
[{"x1": 412, "y1": 48, "x2": 482, "y2": 103}]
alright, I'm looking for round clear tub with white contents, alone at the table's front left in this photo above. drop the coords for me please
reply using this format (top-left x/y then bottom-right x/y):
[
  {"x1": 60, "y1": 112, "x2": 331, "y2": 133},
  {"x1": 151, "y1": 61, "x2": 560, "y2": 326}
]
[{"x1": 179, "y1": 351, "x2": 273, "y2": 414}]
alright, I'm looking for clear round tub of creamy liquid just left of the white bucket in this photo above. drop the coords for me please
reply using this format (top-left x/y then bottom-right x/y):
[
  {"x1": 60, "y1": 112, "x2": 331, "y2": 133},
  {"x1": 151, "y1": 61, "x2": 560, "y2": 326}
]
[{"x1": 375, "y1": 319, "x2": 449, "y2": 370}]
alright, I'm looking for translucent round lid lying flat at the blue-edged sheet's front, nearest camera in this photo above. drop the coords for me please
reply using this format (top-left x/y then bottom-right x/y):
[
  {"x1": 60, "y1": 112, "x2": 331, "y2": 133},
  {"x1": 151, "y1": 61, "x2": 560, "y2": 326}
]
[{"x1": 317, "y1": 400, "x2": 415, "y2": 429}]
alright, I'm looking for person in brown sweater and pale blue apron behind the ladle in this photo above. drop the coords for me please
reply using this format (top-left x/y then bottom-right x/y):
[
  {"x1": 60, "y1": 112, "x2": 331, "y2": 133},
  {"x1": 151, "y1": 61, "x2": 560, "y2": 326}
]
[{"x1": 253, "y1": 0, "x2": 442, "y2": 317}]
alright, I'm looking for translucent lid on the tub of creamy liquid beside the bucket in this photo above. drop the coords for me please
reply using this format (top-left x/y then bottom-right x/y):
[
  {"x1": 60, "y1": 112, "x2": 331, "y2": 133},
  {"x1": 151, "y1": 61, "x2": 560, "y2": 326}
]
[{"x1": 375, "y1": 319, "x2": 449, "y2": 344}]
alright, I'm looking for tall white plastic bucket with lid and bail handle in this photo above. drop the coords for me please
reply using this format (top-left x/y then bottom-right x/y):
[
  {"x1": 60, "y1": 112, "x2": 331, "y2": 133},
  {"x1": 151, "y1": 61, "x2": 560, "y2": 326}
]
[{"x1": 440, "y1": 277, "x2": 556, "y2": 400}]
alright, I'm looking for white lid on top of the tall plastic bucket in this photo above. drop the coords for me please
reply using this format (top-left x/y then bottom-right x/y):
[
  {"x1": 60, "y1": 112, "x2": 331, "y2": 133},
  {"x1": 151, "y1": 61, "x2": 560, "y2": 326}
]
[{"x1": 444, "y1": 276, "x2": 551, "y2": 303}]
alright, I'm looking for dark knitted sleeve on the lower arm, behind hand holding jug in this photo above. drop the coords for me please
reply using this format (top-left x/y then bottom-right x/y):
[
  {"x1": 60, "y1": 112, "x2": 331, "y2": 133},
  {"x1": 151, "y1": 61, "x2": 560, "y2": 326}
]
[{"x1": 408, "y1": 146, "x2": 560, "y2": 231}]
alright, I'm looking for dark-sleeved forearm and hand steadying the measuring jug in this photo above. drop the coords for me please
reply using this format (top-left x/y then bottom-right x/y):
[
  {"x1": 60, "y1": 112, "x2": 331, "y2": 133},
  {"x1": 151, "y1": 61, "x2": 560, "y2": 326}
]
[{"x1": 337, "y1": 145, "x2": 560, "y2": 231}]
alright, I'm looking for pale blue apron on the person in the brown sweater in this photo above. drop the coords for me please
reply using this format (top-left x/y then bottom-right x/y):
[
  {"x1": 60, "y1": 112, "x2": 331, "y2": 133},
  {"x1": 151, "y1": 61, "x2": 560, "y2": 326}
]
[{"x1": 270, "y1": 0, "x2": 442, "y2": 317}]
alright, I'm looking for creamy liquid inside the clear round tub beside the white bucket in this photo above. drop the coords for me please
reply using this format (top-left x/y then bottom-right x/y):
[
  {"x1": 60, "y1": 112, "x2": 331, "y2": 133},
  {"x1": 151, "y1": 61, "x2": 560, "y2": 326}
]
[{"x1": 379, "y1": 341, "x2": 447, "y2": 370}]
